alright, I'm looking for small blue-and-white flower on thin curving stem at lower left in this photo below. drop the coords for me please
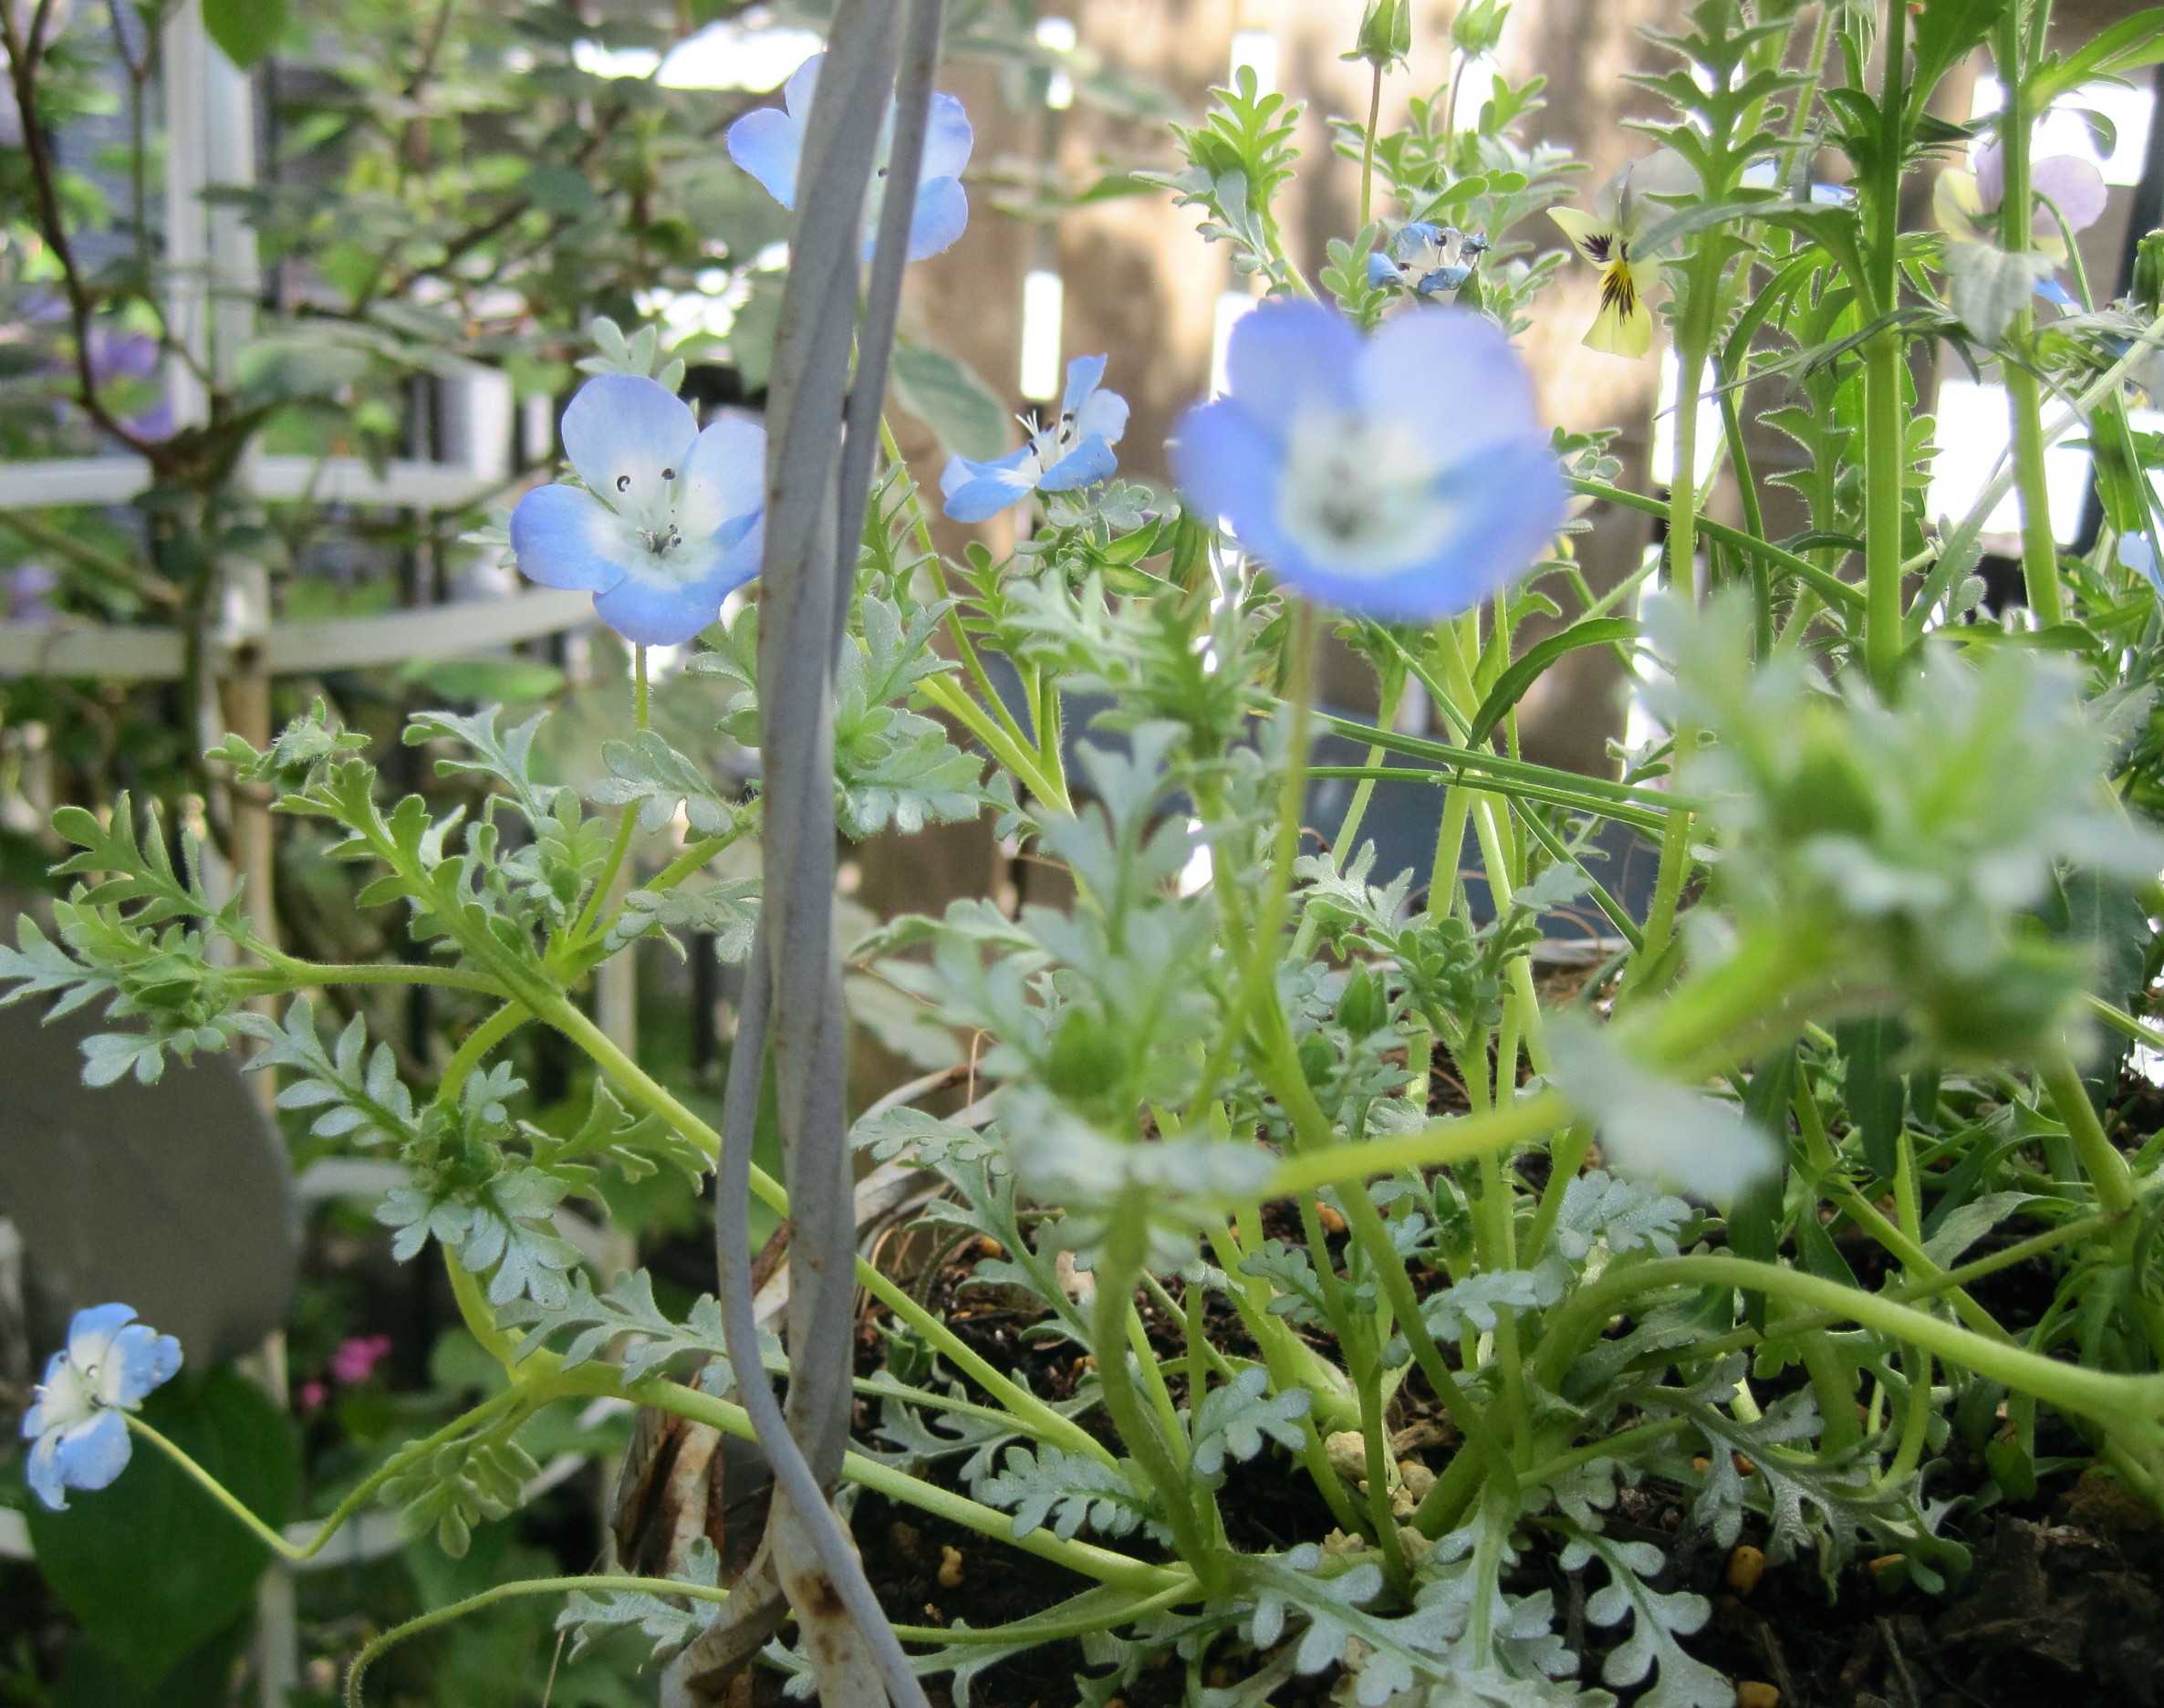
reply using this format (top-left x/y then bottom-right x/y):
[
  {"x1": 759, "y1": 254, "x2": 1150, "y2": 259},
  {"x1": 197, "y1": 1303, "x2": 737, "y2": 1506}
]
[{"x1": 22, "y1": 1306, "x2": 180, "y2": 1513}]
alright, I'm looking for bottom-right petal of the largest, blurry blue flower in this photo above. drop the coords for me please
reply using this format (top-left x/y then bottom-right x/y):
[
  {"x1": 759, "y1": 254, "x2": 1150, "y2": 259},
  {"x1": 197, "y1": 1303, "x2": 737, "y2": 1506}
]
[{"x1": 1272, "y1": 437, "x2": 1569, "y2": 621}]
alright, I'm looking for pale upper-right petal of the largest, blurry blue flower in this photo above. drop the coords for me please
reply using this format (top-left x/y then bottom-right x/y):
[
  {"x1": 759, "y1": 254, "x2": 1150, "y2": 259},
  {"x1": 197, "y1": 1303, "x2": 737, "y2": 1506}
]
[{"x1": 1358, "y1": 307, "x2": 1541, "y2": 461}]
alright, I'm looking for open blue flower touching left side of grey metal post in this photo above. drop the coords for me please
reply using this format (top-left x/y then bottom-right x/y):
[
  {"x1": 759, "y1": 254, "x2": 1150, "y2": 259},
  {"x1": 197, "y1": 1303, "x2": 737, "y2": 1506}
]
[{"x1": 511, "y1": 374, "x2": 766, "y2": 647}]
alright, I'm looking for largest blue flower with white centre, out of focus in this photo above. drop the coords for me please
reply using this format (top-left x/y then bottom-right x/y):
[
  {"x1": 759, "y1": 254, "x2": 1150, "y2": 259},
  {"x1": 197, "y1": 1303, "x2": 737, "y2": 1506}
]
[{"x1": 1170, "y1": 303, "x2": 1569, "y2": 620}]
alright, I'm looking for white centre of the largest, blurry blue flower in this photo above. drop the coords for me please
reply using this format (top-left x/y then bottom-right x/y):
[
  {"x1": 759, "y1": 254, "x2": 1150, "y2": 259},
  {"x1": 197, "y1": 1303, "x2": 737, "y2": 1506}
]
[{"x1": 1276, "y1": 409, "x2": 1478, "y2": 578}]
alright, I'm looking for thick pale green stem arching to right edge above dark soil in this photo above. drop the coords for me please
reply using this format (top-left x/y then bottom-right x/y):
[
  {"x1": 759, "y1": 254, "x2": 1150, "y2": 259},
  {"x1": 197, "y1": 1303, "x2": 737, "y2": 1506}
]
[{"x1": 1535, "y1": 1254, "x2": 2164, "y2": 1437}]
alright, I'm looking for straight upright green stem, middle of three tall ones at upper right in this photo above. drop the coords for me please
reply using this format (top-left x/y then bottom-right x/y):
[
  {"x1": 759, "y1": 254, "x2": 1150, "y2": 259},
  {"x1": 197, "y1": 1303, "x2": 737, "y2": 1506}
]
[{"x1": 1859, "y1": 0, "x2": 1912, "y2": 697}]
